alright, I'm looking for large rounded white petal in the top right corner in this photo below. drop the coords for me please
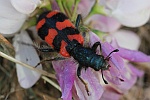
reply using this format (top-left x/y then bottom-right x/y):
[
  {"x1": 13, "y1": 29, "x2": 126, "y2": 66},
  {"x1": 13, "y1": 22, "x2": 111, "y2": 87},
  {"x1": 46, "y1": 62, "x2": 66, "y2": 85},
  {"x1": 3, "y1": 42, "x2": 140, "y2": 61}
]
[{"x1": 105, "y1": 0, "x2": 150, "y2": 27}]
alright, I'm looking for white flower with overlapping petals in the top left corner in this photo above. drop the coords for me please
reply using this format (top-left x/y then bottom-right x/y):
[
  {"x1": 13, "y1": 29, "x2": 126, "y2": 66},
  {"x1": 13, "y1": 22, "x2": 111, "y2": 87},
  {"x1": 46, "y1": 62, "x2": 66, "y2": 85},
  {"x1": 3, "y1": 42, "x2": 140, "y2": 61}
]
[{"x1": 0, "y1": 0, "x2": 40, "y2": 35}]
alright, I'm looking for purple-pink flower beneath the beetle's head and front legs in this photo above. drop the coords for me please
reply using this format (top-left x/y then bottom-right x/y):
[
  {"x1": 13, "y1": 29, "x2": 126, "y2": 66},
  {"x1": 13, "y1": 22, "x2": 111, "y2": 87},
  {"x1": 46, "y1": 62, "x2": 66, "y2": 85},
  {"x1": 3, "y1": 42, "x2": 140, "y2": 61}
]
[{"x1": 53, "y1": 32, "x2": 146, "y2": 100}]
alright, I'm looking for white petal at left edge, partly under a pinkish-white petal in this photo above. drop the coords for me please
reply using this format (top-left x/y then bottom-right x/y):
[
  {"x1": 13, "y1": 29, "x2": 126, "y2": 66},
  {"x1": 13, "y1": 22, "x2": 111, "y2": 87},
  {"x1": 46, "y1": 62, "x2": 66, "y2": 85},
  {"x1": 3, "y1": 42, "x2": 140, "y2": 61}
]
[{"x1": 0, "y1": 0, "x2": 27, "y2": 34}]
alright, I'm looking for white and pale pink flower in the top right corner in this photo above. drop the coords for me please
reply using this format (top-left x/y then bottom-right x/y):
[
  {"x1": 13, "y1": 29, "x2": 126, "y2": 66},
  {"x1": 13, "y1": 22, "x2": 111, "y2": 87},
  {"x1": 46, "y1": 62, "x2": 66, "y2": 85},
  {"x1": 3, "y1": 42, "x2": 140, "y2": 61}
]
[{"x1": 77, "y1": 0, "x2": 150, "y2": 32}]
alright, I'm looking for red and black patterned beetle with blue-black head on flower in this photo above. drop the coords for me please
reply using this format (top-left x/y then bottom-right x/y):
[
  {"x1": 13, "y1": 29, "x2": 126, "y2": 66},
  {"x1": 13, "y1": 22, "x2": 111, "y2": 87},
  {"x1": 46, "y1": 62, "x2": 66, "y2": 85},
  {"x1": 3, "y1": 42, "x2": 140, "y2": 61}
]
[{"x1": 36, "y1": 10, "x2": 119, "y2": 93}]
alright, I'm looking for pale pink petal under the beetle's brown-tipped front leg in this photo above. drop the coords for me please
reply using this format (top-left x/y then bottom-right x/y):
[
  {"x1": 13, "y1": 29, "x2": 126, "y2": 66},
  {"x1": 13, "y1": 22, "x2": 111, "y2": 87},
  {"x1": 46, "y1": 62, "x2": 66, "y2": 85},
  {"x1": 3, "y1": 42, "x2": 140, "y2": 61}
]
[{"x1": 75, "y1": 68, "x2": 103, "y2": 100}]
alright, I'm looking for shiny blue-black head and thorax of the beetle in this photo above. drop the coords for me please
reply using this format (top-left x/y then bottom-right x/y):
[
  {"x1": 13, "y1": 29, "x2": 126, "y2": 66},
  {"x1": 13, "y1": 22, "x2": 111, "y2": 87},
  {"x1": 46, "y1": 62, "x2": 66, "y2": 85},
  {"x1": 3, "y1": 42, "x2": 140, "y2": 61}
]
[{"x1": 66, "y1": 41, "x2": 107, "y2": 71}]
